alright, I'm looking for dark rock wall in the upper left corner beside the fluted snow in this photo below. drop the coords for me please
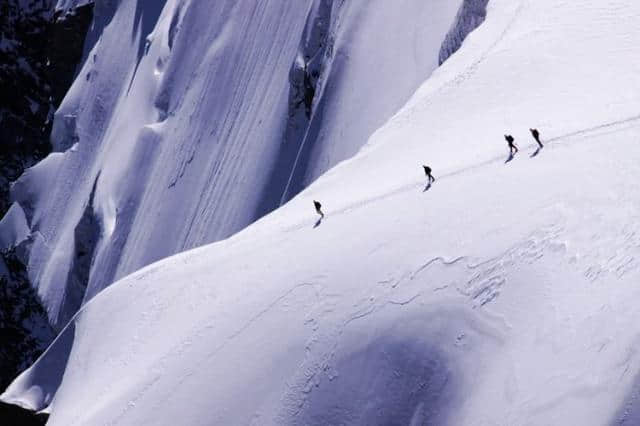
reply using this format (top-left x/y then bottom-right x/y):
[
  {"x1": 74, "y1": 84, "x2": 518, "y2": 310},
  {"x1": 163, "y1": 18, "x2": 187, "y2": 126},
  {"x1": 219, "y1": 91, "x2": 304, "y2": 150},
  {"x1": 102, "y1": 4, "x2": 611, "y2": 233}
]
[{"x1": 0, "y1": 0, "x2": 93, "y2": 217}]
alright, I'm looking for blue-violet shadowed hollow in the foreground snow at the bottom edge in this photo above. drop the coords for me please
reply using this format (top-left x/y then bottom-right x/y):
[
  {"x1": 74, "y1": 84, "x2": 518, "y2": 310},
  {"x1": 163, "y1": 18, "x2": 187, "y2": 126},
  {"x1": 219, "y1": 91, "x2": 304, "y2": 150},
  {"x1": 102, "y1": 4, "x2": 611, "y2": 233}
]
[{"x1": 294, "y1": 334, "x2": 457, "y2": 425}]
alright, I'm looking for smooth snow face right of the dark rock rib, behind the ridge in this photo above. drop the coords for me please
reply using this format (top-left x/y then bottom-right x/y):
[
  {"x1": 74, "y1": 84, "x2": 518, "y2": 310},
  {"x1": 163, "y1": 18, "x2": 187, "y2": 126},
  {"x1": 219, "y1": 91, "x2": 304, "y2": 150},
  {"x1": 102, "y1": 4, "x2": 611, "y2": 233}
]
[{"x1": 272, "y1": 0, "x2": 463, "y2": 203}]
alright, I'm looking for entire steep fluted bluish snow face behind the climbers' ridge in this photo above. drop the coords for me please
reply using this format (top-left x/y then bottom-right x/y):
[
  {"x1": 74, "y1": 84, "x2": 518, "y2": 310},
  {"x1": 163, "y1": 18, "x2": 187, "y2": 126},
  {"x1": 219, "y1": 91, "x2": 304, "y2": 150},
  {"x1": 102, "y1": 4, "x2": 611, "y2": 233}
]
[{"x1": 5, "y1": 0, "x2": 460, "y2": 327}]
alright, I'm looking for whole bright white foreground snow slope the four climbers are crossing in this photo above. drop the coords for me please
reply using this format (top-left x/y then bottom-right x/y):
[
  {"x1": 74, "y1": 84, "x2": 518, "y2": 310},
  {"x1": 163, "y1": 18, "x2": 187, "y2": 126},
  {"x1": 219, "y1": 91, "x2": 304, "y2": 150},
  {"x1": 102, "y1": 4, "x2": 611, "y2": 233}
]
[{"x1": 2, "y1": 0, "x2": 640, "y2": 426}]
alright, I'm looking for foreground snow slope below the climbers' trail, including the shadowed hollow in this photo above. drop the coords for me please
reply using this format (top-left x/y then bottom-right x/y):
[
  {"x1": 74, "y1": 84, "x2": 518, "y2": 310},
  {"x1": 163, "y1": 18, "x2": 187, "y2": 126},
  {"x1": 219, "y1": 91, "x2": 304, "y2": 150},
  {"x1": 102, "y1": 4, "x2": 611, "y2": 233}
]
[{"x1": 4, "y1": 118, "x2": 640, "y2": 425}]
